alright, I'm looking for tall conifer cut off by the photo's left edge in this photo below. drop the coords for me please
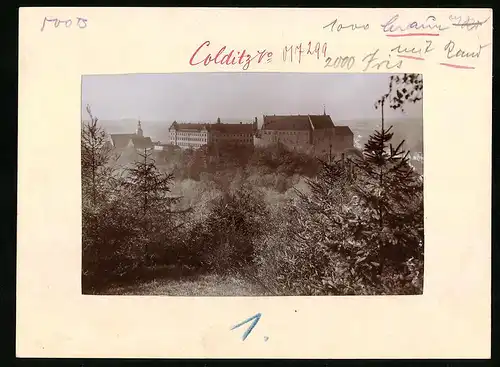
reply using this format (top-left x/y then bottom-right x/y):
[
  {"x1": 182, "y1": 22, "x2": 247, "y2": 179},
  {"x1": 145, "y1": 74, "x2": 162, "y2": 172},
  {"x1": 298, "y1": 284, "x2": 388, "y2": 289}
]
[{"x1": 81, "y1": 106, "x2": 136, "y2": 292}]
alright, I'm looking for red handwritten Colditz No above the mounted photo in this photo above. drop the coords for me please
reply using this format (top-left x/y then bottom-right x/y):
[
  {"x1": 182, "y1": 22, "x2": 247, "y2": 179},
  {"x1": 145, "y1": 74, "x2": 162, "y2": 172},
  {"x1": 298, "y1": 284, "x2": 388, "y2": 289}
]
[{"x1": 189, "y1": 41, "x2": 273, "y2": 70}]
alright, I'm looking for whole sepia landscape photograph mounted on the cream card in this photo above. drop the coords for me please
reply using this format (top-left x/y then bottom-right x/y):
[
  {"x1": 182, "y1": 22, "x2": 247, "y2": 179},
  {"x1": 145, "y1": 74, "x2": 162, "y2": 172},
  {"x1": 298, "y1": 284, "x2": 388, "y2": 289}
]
[{"x1": 81, "y1": 72, "x2": 424, "y2": 296}]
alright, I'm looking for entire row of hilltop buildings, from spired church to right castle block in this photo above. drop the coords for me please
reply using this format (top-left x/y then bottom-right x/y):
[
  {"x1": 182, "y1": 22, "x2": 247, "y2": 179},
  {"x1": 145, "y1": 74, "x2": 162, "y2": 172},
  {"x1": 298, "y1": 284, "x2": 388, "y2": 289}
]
[{"x1": 109, "y1": 111, "x2": 354, "y2": 162}]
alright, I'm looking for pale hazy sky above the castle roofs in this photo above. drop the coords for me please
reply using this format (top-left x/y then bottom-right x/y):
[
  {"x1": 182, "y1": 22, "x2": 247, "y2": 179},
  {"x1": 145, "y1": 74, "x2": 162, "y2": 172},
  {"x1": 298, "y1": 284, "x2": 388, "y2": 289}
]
[{"x1": 82, "y1": 72, "x2": 422, "y2": 121}]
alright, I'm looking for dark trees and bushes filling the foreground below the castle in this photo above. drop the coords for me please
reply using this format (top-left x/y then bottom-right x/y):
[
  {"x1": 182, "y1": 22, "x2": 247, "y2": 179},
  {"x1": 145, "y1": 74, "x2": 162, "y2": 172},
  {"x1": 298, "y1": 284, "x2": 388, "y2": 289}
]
[{"x1": 81, "y1": 74, "x2": 424, "y2": 296}]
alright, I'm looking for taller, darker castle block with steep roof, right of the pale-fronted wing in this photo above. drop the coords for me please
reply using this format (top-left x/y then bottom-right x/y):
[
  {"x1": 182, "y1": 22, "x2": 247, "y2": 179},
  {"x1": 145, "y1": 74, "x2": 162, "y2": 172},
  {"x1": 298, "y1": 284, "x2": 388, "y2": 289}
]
[{"x1": 256, "y1": 112, "x2": 354, "y2": 158}]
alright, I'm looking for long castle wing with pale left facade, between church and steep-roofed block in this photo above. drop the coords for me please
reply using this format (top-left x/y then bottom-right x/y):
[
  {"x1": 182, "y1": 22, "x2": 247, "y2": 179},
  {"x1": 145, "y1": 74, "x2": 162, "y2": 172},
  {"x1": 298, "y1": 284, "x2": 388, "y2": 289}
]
[{"x1": 169, "y1": 118, "x2": 257, "y2": 149}]
